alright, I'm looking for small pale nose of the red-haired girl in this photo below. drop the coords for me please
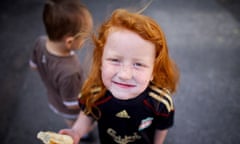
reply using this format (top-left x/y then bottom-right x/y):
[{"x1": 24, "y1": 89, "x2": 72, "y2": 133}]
[{"x1": 118, "y1": 65, "x2": 133, "y2": 80}]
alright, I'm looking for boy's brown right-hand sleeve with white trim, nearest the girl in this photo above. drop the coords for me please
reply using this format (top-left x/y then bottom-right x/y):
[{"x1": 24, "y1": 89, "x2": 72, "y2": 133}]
[{"x1": 59, "y1": 73, "x2": 82, "y2": 107}]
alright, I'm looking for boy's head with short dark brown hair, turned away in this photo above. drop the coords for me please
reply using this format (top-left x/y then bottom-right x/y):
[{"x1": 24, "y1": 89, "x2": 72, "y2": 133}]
[{"x1": 43, "y1": 0, "x2": 93, "y2": 41}]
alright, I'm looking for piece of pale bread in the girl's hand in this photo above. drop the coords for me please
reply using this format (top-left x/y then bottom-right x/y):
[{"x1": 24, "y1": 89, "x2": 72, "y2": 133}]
[{"x1": 37, "y1": 131, "x2": 73, "y2": 144}]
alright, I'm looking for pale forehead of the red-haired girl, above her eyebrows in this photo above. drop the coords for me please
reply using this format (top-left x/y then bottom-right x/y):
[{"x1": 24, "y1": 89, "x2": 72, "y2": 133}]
[{"x1": 103, "y1": 29, "x2": 155, "y2": 59}]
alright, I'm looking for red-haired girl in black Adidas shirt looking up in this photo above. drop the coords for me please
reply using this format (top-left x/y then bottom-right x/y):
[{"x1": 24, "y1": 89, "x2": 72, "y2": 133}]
[{"x1": 60, "y1": 9, "x2": 179, "y2": 144}]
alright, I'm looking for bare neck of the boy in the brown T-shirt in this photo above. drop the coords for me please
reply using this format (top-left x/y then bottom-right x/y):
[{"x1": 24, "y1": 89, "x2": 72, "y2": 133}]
[{"x1": 46, "y1": 39, "x2": 71, "y2": 56}]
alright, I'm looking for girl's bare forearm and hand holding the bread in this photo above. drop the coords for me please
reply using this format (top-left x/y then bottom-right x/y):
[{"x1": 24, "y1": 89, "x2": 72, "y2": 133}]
[{"x1": 59, "y1": 111, "x2": 94, "y2": 144}]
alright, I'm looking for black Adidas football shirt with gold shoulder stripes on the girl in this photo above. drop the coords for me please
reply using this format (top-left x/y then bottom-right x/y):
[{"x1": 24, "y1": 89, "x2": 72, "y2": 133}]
[{"x1": 81, "y1": 85, "x2": 174, "y2": 144}]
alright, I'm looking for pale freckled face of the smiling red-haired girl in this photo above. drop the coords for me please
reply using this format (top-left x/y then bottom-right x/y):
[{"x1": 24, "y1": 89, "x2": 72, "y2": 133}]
[{"x1": 101, "y1": 29, "x2": 155, "y2": 99}]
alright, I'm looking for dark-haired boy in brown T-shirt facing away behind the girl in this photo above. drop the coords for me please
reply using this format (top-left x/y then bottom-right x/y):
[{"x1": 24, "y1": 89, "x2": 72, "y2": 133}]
[{"x1": 29, "y1": 0, "x2": 93, "y2": 138}]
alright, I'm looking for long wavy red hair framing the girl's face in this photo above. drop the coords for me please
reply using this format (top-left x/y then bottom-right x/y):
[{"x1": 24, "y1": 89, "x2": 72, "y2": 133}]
[{"x1": 80, "y1": 9, "x2": 179, "y2": 117}]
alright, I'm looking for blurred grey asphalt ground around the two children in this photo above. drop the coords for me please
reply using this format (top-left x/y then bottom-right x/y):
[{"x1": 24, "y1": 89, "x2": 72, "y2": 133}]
[{"x1": 0, "y1": 0, "x2": 240, "y2": 144}]
